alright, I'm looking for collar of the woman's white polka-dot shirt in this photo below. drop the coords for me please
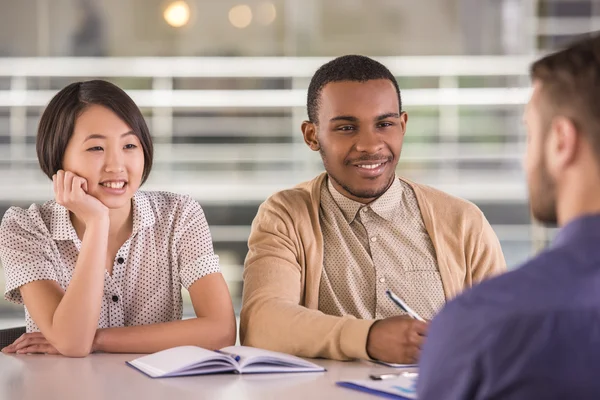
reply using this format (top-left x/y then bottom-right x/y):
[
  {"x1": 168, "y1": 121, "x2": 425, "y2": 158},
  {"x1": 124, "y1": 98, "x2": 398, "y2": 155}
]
[{"x1": 50, "y1": 190, "x2": 156, "y2": 240}]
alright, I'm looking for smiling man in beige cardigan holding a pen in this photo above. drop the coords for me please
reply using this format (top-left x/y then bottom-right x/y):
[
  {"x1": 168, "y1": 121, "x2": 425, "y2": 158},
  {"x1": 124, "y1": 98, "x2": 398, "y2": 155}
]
[{"x1": 240, "y1": 55, "x2": 505, "y2": 363}]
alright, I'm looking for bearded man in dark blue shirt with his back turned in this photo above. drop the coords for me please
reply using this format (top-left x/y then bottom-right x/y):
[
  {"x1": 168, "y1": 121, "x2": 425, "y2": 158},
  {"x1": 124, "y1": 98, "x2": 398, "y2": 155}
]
[{"x1": 418, "y1": 35, "x2": 600, "y2": 400}]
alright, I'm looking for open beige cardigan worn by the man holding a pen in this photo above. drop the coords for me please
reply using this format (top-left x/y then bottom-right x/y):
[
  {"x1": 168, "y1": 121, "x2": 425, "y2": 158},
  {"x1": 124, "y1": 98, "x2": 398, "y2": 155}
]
[{"x1": 240, "y1": 173, "x2": 506, "y2": 360}]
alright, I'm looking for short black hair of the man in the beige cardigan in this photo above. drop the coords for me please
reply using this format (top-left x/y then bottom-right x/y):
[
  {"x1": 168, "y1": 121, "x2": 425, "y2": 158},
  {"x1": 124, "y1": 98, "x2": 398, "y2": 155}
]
[{"x1": 306, "y1": 55, "x2": 402, "y2": 123}]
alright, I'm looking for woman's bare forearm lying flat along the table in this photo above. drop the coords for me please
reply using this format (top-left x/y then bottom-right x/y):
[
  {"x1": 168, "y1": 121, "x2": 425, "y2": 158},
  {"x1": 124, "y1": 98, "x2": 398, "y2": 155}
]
[{"x1": 92, "y1": 317, "x2": 236, "y2": 353}]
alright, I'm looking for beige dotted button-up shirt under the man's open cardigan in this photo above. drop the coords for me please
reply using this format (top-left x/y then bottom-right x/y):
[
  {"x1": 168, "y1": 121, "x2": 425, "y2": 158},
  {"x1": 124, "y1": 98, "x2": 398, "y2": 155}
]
[{"x1": 319, "y1": 179, "x2": 445, "y2": 319}]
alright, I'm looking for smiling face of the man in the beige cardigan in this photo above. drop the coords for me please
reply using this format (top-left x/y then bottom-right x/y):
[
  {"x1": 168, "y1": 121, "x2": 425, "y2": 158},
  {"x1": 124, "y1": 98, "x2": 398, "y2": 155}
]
[{"x1": 303, "y1": 79, "x2": 407, "y2": 204}]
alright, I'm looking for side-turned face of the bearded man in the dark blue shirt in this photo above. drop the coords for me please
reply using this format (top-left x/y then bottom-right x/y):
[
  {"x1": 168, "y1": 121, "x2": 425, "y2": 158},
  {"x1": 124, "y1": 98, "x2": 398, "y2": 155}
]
[{"x1": 524, "y1": 82, "x2": 557, "y2": 224}]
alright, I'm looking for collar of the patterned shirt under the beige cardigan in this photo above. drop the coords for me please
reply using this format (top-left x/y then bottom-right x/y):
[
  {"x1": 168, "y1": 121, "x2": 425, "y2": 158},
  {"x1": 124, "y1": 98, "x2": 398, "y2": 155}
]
[{"x1": 327, "y1": 177, "x2": 402, "y2": 224}]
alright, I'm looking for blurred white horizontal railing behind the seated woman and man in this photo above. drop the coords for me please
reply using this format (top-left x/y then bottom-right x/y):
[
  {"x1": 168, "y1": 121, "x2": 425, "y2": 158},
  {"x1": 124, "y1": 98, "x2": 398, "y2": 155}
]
[{"x1": 0, "y1": 56, "x2": 542, "y2": 314}]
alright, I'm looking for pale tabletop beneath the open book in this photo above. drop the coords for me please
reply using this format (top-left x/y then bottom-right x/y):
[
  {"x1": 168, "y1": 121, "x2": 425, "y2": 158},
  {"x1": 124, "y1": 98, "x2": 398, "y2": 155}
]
[{"x1": 0, "y1": 354, "x2": 414, "y2": 400}]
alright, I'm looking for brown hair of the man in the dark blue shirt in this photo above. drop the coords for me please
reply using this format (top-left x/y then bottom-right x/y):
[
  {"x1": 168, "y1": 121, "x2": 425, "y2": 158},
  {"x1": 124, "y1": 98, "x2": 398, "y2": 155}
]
[{"x1": 530, "y1": 34, "x2": 600, "y2": 152}]
